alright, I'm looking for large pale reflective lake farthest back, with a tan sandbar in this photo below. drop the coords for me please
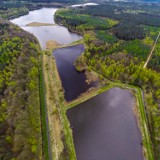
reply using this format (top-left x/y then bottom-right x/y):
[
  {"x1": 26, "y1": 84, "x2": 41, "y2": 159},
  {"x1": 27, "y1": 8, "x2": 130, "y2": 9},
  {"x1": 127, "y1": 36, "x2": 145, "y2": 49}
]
[{"x1": 10, "y1": 8, "x2": 82, "y2": 49}]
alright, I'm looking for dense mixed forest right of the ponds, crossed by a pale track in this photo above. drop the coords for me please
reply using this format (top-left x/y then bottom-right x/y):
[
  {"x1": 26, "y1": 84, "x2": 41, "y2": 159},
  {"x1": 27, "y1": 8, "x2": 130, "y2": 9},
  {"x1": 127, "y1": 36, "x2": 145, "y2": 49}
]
[{"x1": 55, "y1": 2, "x2": 160, "y2": 160}]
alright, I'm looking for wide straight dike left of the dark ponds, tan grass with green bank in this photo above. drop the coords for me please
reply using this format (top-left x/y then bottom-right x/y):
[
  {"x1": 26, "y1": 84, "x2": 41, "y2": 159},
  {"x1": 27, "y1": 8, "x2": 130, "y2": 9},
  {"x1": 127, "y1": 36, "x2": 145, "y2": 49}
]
[{"x1": 43, "y1": 50, "x2": 76, "y2": 160}]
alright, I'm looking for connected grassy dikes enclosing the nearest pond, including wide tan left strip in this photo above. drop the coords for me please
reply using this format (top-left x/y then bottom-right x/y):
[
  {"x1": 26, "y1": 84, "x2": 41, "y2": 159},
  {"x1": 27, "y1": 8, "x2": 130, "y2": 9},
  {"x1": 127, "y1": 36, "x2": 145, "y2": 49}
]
[{"x1": 43, "y1": 41, "x2": 154, "y2": 160}]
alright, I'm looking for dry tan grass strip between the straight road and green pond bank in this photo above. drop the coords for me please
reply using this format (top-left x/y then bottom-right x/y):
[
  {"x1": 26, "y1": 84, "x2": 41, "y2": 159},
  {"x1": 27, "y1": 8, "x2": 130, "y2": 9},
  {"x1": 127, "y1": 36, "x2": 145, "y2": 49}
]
[{"x1": 43, "y1": 55, "x2": 63, "y2": 160}]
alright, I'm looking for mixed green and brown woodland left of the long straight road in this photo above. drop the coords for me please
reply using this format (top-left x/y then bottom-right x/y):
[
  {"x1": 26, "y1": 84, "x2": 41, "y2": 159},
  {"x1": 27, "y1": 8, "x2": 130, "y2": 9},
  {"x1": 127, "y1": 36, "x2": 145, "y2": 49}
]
[{"x1": 0, "y1": 19, "x2": 42, "y2": 160}]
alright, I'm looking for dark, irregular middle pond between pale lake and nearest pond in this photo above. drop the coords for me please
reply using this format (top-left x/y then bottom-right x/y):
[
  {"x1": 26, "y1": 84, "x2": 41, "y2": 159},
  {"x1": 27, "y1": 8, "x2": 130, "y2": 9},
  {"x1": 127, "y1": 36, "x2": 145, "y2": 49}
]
[{"x1": 53, "y1": 44, "x2": 96, "y2": 101}]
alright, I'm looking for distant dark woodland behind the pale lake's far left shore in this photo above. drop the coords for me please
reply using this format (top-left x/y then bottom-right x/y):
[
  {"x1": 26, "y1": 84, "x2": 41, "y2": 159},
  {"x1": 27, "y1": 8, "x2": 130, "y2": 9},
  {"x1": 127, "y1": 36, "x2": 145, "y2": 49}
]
[{"x1": 0, "y1": 0, "x2": 77, "y2": 19}]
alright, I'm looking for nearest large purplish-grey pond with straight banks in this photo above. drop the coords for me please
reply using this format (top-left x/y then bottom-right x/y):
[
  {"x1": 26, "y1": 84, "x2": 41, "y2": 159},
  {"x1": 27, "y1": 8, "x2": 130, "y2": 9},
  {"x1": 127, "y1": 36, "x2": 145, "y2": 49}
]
[{"x1": 67, "y1": 88, "x2": 143, "y2": 160}]
